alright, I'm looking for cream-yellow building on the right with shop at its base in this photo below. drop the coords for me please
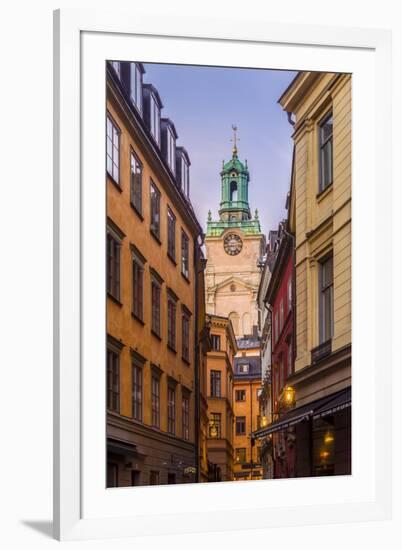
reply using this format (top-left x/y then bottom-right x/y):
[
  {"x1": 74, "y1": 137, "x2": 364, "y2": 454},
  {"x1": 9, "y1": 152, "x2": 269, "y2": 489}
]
[{"x1": 254, "y1": 72, "x2": 352, "y2": 477}]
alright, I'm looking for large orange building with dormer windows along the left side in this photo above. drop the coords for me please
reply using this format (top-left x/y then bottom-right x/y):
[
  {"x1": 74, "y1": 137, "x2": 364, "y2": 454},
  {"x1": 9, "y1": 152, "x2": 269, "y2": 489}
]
[{"x1": 106, "y1": 62, "x2": 205, "y2": 487}]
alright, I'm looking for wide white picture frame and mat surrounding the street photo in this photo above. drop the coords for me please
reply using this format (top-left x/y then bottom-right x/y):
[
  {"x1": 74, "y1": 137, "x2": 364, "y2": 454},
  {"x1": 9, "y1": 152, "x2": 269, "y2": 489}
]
[{"x1": 54, "y1": 10, "x2": 391, "y2": 540}]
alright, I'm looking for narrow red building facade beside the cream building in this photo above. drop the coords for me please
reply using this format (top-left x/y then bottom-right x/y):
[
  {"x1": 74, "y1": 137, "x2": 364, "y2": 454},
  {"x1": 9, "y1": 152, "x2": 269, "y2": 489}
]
[{"x1": 266, "y1": 222, "x2": 296, "y2": 478}]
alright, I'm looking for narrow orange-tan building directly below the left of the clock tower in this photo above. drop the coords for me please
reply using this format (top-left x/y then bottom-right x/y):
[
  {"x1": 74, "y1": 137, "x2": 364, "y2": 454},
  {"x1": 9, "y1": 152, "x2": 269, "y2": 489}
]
[{"x1": 207, "y1": 315, "x2": 237, "y2": 481}]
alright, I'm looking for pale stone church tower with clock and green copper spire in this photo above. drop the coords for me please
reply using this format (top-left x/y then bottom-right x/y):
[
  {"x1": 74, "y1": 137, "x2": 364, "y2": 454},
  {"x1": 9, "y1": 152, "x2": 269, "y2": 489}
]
[{"x1": 205, "y1": 126, "x2": 265, "y2": 339}]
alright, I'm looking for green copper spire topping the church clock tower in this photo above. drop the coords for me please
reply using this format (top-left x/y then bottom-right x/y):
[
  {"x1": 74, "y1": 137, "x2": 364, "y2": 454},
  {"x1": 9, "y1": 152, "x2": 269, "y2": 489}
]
[{"x1": 207, "y1": 125, "x2": 261, "y2": 236}]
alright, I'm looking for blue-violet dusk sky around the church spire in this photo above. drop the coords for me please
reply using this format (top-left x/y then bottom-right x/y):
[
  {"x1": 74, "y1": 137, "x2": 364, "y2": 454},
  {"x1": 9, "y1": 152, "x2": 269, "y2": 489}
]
[{"x1": 144, "y1": 64, "x2": 296, "y2": 233}]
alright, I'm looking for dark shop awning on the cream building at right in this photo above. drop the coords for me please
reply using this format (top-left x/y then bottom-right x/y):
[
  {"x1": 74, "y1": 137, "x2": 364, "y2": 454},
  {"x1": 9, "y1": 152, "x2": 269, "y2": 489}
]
[{"x1": 251, "y1": 388, "x2": 352, "y2": 439}]
